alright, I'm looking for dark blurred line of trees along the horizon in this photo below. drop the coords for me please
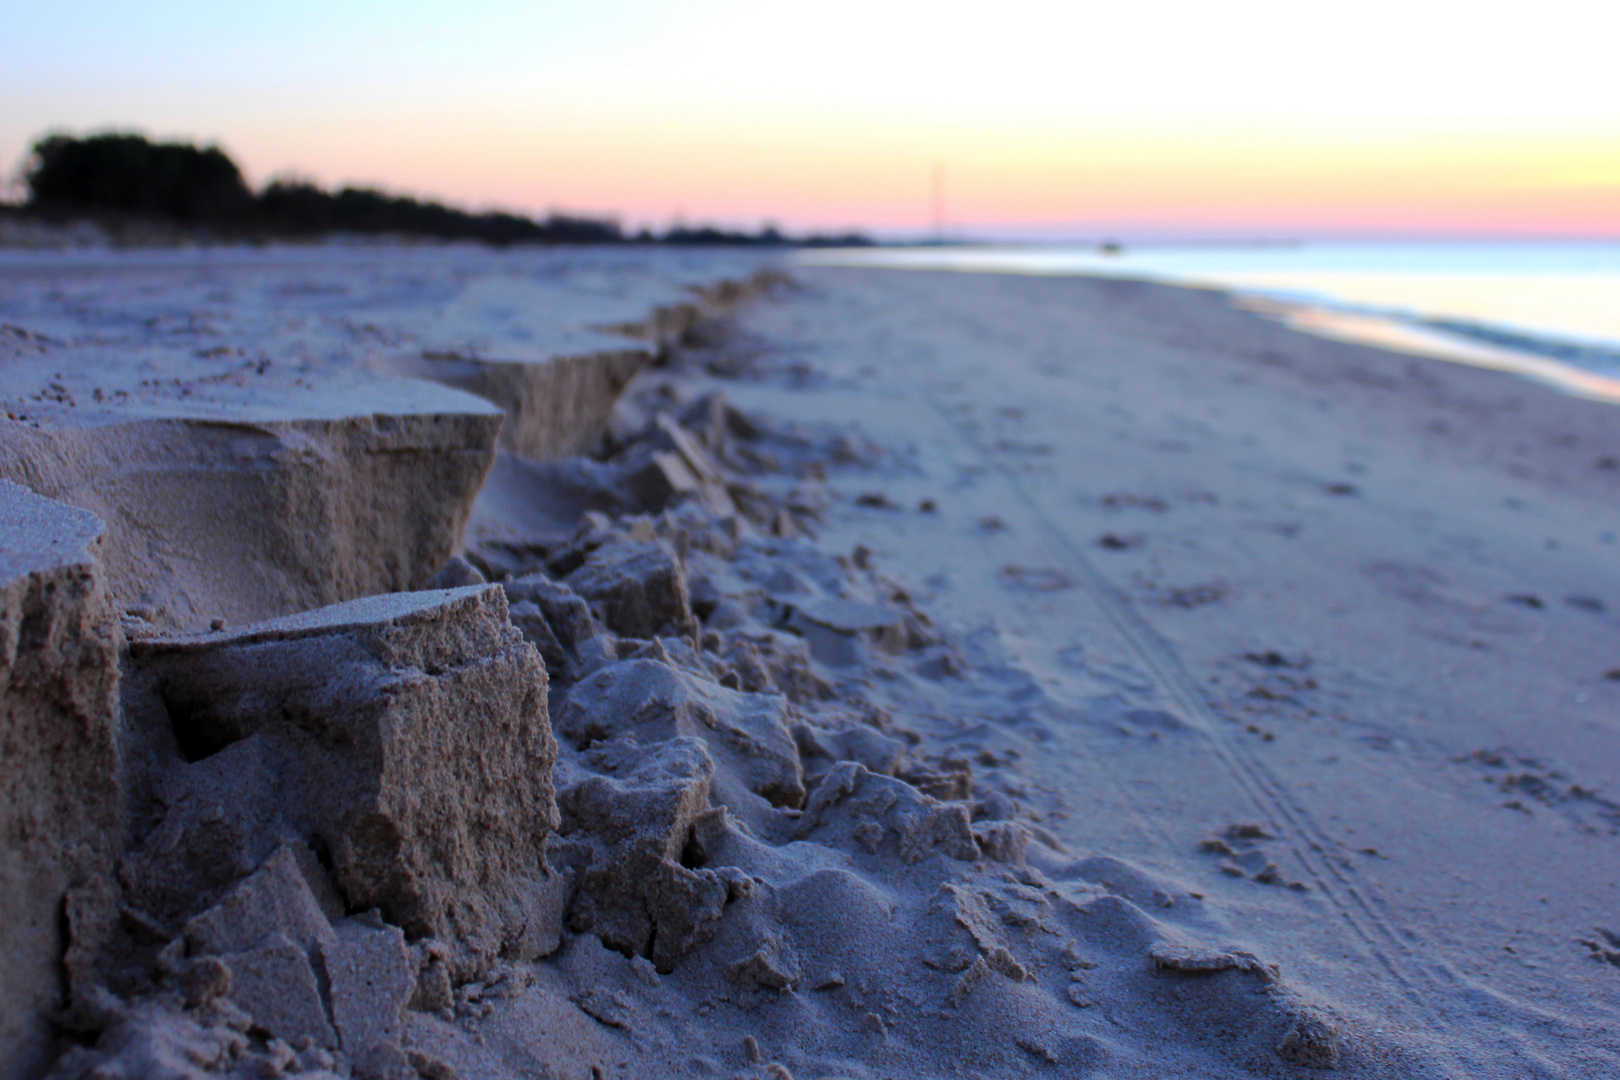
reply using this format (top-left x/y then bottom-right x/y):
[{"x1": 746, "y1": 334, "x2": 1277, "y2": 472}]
[{"x1": 12, "y1": 133, "x2": 872, "y2": 246}]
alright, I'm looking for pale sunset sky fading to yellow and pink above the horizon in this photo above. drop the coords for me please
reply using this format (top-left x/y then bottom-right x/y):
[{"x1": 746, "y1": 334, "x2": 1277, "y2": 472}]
[{"x1": 0, "y1": 0, "x2": 1620, "y2": 238}]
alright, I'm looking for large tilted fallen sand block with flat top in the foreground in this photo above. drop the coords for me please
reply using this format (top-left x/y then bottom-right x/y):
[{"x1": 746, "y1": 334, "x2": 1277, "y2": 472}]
[{"x1": 128, "y1": 585, "x2": 556, "y2": 954}]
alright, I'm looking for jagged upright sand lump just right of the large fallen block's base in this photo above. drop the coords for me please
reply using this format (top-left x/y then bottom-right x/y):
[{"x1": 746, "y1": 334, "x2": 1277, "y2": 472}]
[{"x1": 559, "y1": 737, "x2": 729, "y2": 972}]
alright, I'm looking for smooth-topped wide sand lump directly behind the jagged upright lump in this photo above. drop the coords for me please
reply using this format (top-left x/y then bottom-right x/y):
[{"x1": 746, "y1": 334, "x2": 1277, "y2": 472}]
[{"x1": 557, "y1": 659, "x2": 805, "y2": 806}]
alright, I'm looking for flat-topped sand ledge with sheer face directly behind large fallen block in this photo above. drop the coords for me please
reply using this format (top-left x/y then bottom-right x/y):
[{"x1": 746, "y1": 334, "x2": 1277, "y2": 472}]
[{"x1": 0, "y1": 376, "x2": 501, "y2": 631}]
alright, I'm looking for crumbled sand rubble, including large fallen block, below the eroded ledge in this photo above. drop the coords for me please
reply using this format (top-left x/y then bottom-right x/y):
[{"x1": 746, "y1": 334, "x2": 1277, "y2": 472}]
[{"x1": 8, "y1": 255, "x2": 1396, "y2": 1080}]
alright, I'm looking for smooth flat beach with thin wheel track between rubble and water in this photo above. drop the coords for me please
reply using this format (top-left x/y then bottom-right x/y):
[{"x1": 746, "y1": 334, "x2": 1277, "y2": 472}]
[{"x1": 716, "y1": 270, "x2": 1620, "y2": 1075}]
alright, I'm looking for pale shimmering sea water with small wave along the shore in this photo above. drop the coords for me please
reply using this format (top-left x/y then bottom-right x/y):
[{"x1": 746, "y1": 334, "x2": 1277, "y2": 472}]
[{"x1": 800, "y1": 241, "x2": 1620, "y2": 402}]
